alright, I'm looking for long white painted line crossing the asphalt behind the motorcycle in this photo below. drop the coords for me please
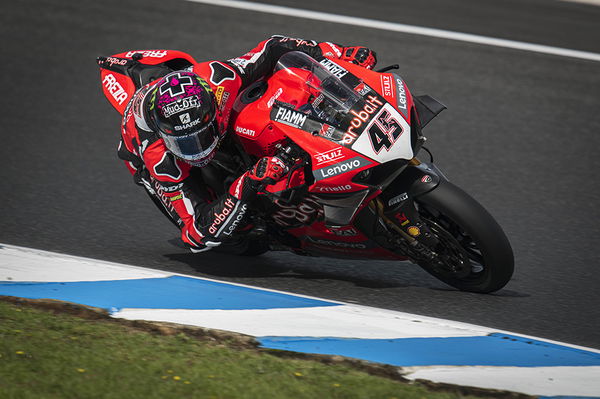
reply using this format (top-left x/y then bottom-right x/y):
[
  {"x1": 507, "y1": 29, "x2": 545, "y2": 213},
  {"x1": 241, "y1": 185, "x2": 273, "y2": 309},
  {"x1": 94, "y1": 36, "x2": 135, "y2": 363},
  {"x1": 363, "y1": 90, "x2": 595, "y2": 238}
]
[{"x1": 187, "y1": 0, "x2": 600, "y2": 61}]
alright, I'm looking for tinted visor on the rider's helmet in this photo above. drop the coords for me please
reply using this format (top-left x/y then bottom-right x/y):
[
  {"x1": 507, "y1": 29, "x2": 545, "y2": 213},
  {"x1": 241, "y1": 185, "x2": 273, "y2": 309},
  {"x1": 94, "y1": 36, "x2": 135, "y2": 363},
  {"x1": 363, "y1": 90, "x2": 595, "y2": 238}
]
[{"x1": 161, "y1": 119, "x2": 219, "y2": 161}]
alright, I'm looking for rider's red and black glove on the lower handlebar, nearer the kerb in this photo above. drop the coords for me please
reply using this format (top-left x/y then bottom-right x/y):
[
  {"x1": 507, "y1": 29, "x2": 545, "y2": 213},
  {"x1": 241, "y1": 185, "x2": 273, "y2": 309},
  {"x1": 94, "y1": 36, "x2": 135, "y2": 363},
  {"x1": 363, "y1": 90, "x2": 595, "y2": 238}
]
[{"x1": 229, "y1": 157, "x2": 289, "y2": 201}]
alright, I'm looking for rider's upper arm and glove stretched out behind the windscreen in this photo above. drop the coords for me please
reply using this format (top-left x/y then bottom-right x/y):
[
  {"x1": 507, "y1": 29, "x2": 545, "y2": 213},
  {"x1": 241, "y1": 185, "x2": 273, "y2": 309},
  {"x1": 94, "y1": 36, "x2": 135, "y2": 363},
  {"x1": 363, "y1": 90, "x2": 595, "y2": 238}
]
[{"x1": 226, "y1": 36, "x2": 377, "y2": 89}]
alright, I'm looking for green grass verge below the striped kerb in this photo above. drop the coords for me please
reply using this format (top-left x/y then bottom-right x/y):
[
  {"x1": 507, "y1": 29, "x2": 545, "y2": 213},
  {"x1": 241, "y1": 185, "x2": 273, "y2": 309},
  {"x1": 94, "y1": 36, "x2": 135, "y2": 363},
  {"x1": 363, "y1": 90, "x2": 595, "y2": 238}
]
[{"x1": 0, "y1": 301, "x2": 488, "y2": 399}]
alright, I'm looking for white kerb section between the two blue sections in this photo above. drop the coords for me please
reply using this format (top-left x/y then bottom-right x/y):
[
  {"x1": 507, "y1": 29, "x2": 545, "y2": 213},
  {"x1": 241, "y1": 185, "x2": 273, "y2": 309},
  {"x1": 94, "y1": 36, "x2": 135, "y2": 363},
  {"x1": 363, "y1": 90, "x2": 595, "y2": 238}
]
[{"x1": 112, "y1": 305, "x2": 496, "y2": 339}]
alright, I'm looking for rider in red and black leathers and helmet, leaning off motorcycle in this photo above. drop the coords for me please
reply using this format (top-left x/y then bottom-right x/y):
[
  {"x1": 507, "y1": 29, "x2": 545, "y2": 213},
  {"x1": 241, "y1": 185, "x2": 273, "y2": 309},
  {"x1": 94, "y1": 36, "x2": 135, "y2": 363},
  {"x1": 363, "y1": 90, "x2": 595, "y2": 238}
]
[{"x1": 118, "y1": 36, "x2": 377, "y2": 252}]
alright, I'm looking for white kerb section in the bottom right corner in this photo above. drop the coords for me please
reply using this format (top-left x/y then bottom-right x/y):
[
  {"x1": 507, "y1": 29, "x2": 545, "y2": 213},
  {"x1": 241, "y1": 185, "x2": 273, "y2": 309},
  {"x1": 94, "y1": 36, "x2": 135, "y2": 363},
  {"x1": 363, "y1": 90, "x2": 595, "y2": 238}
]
[{"x1": 403, "y1": 366, "x2": 600, "y2": 397}]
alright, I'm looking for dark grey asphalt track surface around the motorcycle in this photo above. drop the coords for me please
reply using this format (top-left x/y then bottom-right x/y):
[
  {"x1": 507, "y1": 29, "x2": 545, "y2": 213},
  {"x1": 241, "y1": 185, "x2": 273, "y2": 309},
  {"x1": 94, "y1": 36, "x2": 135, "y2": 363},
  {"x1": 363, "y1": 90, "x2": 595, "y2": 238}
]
[{"x1": 0, "y1": 0, "x2": 600, "y2": 348}]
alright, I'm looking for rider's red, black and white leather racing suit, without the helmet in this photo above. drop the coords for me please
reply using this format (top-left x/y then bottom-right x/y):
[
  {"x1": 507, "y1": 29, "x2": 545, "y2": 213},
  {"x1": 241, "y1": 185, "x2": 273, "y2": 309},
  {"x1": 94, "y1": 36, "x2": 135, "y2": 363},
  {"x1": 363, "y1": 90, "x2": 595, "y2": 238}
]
[{"x1": 118, "y1": 36, "x2": 368, "y2": 250}]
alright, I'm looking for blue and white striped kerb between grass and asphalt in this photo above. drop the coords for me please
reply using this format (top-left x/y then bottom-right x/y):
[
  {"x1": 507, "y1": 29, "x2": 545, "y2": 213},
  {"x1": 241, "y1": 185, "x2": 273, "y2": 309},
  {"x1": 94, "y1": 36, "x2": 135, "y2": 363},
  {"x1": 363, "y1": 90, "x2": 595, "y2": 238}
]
[{"x1": 0, "y1": 245, "x2": 600, "y2": 397}]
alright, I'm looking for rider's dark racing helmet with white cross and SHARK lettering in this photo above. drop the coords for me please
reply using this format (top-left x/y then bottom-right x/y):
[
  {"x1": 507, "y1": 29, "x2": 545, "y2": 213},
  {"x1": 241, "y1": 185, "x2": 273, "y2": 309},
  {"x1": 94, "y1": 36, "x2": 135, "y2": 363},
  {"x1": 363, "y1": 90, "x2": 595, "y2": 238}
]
[{"x1": 148, "y1": 71, "x2": 221, "y2": 167}]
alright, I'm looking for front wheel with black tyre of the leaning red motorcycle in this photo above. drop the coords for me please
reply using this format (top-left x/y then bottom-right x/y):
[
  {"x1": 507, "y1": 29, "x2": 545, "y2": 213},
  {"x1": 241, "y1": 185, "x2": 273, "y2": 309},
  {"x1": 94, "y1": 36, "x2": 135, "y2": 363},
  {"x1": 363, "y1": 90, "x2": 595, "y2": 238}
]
[{"x1": 416, "y1": 181, "x2": 514, "y2": 293}]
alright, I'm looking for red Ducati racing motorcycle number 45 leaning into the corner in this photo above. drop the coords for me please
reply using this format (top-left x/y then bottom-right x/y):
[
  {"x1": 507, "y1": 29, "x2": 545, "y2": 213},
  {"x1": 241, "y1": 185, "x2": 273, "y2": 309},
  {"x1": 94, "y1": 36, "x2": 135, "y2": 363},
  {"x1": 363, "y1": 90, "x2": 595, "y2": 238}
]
[{"x1": 98, "y1": 50, "x2": 514, "y2": 293}]
